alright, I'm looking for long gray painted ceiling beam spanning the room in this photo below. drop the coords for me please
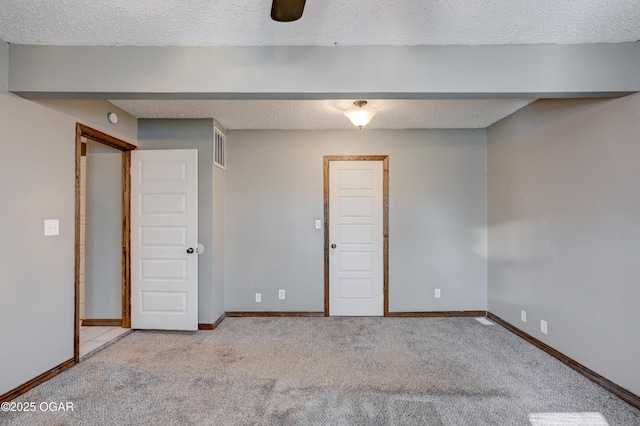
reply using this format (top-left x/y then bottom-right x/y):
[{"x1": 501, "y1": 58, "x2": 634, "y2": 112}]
[{"x1": 9, "y1": 43, "x2": 640, "y2": 99}]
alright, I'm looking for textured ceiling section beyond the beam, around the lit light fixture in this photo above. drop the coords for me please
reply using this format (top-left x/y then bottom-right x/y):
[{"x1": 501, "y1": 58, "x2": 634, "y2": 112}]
[{"x1": 111, "y1": 99, "x2": 531, "y2": 130}]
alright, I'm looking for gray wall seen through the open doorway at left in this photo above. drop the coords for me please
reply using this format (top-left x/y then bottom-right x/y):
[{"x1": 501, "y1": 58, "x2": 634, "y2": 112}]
[{"x1": 85, "y1": 140, "x2": 122, "y2": 319}]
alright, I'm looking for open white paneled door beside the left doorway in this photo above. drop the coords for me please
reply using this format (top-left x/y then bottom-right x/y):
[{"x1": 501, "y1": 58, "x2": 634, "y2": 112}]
[{"x1": 131, "y1": 149, "x2": 198, "y2": 330}]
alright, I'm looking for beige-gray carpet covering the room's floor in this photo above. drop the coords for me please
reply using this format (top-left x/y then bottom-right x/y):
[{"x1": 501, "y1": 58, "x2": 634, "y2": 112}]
[{"x1": 0, "y1": 318, "x2": 640, "y2": 426}]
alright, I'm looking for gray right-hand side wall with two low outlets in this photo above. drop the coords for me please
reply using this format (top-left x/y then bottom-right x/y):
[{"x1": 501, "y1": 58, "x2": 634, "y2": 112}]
[{"x1": 487, "y1": 94, "x2": 640, "y2": 395}]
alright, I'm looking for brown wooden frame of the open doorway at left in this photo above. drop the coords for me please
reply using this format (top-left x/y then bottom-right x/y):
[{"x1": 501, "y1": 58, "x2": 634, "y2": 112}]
[{"x1": 73, "y1": 123, "x2": 136, "y2": 363}]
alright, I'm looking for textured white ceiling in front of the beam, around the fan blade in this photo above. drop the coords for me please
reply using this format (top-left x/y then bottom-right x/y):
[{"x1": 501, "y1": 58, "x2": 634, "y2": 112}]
[{"x1": 0, "y1": 0, "x2": 640, "y2": 46}]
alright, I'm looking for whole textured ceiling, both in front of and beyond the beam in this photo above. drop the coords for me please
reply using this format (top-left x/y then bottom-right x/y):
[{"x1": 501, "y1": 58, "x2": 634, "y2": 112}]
[{"x1": 0, "y1": 0, "x2": 640, "y2": 129}]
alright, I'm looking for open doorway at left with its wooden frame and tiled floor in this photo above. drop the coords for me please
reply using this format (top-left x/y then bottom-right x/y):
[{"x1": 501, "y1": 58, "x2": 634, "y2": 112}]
[{"x1": 74, "y1": 123, "x2": 135, "y2": 362}]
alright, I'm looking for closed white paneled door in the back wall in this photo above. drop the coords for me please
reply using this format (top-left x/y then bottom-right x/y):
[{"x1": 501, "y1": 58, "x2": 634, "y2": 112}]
[{"x1": 329, "y1": 161, "x2": 384, "y2": 316}]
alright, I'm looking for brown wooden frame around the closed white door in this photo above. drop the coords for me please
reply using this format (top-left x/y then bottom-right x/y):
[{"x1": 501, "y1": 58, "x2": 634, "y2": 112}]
[{"x1": 324, "y1": 155, "x2": 389, "y2": 317}]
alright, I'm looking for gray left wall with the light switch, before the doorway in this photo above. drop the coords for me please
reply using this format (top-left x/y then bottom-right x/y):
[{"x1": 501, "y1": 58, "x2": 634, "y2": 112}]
[{"x1": 0, "y1": 41, "x2": 75, "y2": 394}]
